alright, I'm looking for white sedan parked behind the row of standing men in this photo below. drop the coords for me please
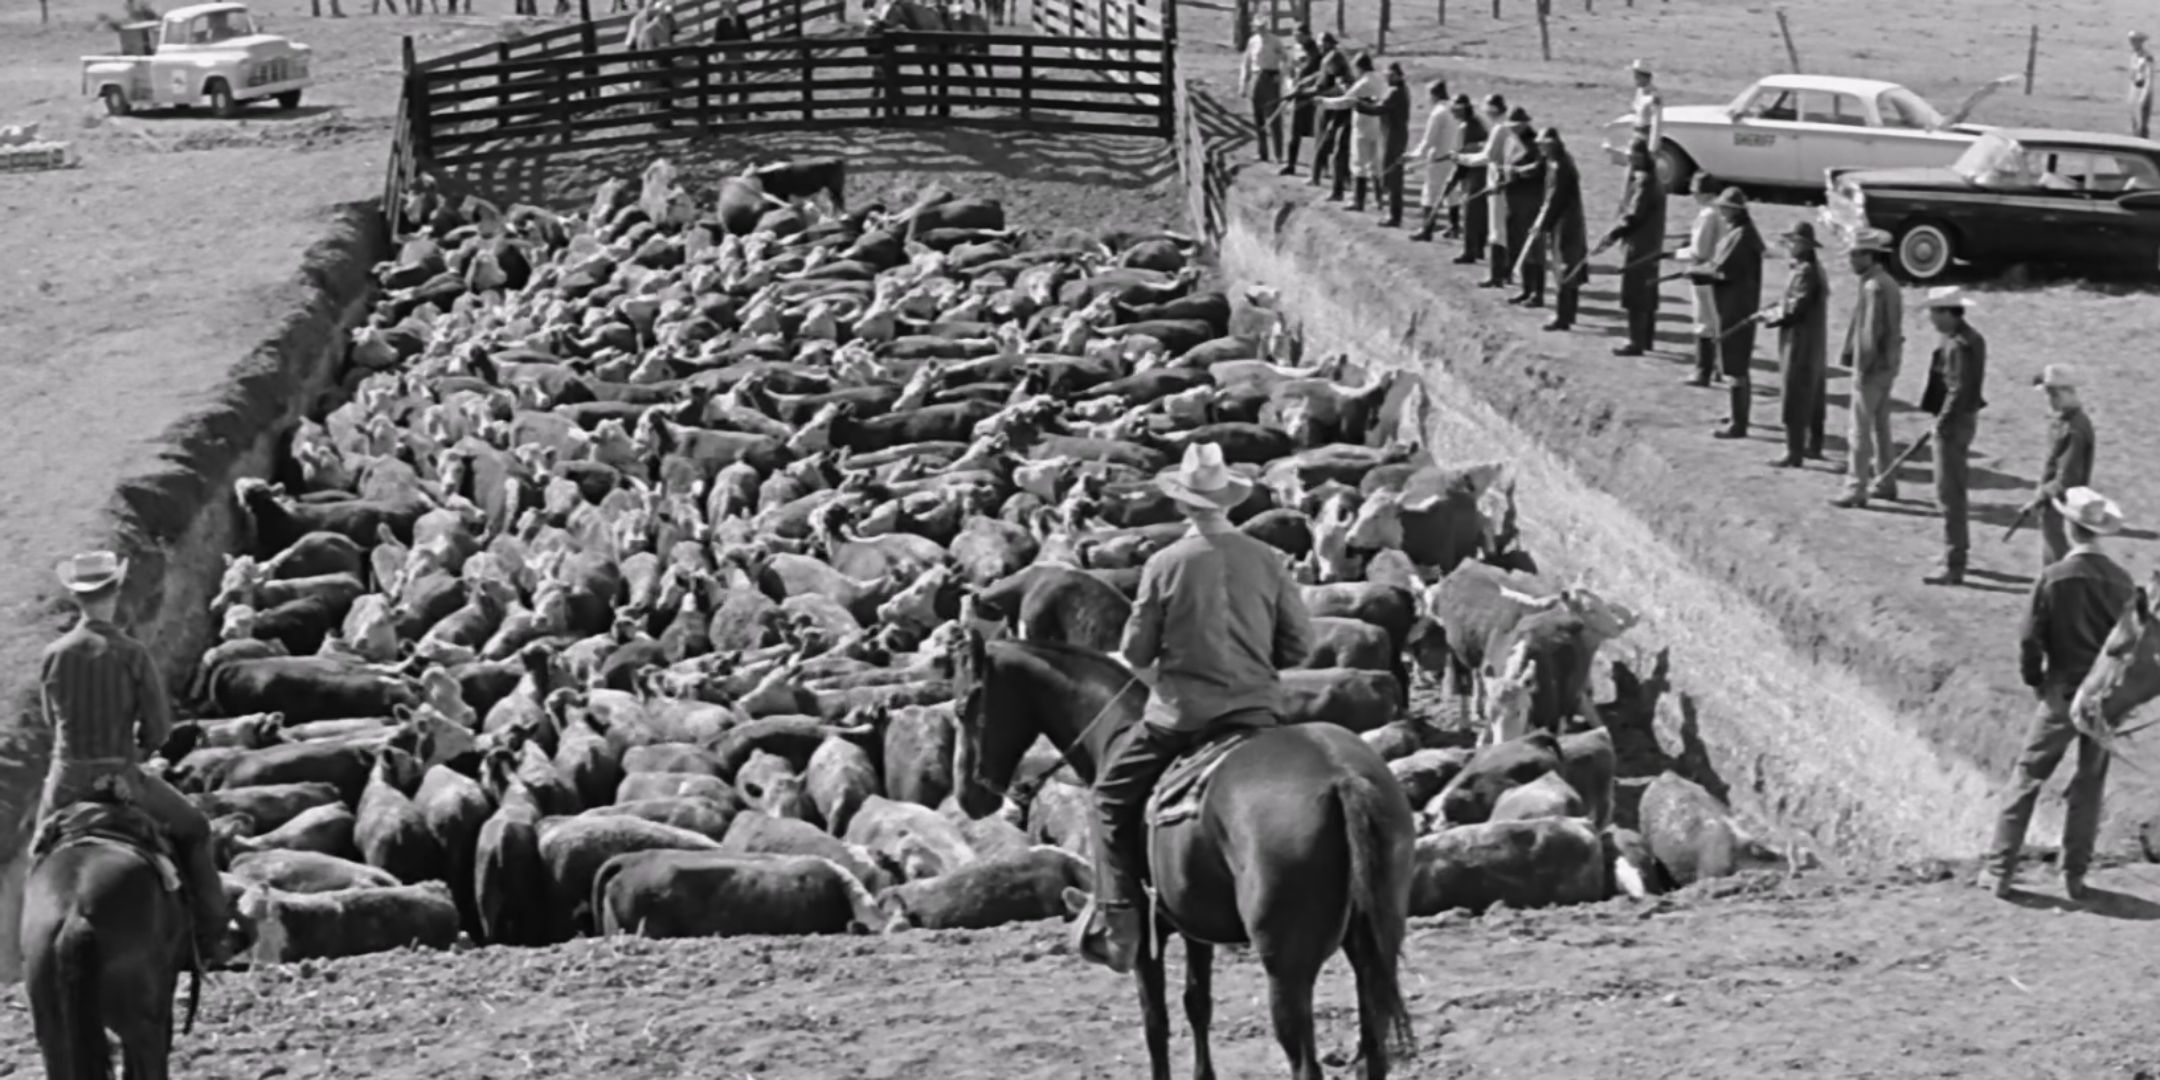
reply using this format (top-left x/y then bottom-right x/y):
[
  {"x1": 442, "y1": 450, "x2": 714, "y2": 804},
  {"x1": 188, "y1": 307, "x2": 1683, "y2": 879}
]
[{"x1": 1605, "y1": 76, "x2": 2017, "y2": 197}]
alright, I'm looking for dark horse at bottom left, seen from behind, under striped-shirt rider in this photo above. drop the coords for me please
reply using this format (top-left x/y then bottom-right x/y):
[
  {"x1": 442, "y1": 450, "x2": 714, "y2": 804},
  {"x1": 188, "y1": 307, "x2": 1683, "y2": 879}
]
[{"x1": 22, "y1": 799, "x2": 201, "y2": 1080}]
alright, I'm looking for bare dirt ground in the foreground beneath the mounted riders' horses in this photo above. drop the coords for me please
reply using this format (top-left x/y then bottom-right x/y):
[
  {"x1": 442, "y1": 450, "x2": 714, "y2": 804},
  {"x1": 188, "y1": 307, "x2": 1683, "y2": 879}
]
[{"x1": 0, "y1": 866, "x2": 2160, "y2": 1080}]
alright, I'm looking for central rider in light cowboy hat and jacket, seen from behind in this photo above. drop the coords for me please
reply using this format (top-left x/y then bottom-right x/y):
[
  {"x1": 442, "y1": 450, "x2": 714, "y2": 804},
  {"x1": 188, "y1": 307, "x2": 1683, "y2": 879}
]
[{"x1": 1074, "y1": 443, "x2": 1313, "y2": 972}]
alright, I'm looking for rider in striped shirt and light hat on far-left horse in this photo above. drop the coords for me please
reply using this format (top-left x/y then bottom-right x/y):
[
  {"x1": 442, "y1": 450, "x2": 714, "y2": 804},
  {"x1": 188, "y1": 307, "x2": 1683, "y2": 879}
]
[{"x1": 39, "y1": 551, "x2": 227, "y2": 968}]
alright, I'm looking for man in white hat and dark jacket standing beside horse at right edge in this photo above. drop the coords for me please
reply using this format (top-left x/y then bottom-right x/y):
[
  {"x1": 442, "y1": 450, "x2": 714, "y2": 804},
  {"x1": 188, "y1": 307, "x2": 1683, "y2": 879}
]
[{"x1": 1979, "y1": 488, "x2": 2136, "y2": 901}]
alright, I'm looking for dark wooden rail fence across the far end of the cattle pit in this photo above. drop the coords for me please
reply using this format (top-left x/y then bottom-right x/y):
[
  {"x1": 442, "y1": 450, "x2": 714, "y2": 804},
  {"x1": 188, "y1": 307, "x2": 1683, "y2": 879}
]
[{"x1": 382, "y1": 0, "x2": 1179, "y2": 212}]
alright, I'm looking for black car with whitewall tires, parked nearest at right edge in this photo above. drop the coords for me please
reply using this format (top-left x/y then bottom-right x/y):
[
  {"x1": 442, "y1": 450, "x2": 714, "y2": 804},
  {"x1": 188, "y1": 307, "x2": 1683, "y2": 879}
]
[{"x1": 1821, "y1": 127, "x2": 2160, "y2": 281}]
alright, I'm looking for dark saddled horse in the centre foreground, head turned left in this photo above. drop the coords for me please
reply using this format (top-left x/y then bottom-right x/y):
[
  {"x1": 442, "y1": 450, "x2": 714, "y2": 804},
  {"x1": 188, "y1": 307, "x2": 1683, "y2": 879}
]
[{"x1": 953, "y1": 620, "x2": 1417, "y2": 1080}]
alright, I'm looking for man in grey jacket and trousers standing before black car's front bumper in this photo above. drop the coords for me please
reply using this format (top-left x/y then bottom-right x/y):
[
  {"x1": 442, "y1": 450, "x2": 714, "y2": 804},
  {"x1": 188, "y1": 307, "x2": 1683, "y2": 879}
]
[{"x1": 1832, "y1": 229, "x2": 1905, "y2": 510}]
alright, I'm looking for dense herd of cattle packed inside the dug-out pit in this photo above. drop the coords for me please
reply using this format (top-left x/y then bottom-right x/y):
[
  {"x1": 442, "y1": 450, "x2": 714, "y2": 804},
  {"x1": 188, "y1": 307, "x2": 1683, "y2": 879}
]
[{"x1": 151, "y1": 162, "x2": 1747, "y2": 961}]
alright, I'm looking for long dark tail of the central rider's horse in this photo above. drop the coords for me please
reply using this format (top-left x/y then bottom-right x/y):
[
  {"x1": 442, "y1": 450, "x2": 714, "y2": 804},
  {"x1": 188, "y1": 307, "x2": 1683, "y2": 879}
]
[{"x1": 1335, "y1": 775, "x2": 1415, "y2": 1054}]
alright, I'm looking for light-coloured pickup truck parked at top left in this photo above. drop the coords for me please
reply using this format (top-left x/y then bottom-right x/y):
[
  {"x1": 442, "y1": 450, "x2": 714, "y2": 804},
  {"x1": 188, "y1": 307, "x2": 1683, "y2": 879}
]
[{"x1": 82, "y1": 2, "x2": 313, "y2": 117}]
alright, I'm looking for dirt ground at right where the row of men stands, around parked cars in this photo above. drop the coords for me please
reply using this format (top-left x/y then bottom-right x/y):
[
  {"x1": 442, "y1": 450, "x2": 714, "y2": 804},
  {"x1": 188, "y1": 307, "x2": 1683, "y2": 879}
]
[{"x1": 1182, "y1": 0, "x2": 2160, "y2": 845}]
